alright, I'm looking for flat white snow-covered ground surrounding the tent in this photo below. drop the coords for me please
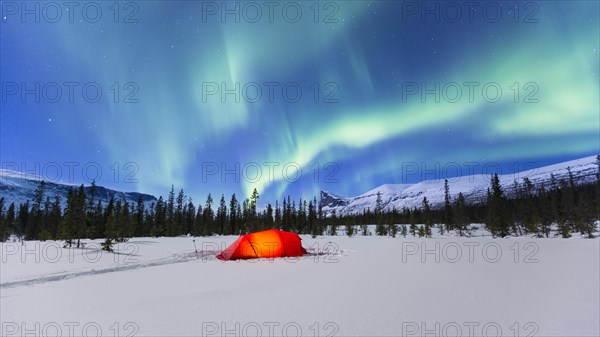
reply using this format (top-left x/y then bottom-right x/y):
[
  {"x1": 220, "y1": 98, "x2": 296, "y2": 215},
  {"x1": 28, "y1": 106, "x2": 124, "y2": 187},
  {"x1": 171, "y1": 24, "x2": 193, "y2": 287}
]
[{"x1": 0, "y1": 232, "x2": 600, "y2": 336}]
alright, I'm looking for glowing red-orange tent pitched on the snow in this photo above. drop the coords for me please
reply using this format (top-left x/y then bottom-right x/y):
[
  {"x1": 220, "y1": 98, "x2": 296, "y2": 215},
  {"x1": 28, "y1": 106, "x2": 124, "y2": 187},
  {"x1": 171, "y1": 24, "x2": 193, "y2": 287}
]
[{"x1": 217, "y1": 229, "x2": 306, "y2": 261}]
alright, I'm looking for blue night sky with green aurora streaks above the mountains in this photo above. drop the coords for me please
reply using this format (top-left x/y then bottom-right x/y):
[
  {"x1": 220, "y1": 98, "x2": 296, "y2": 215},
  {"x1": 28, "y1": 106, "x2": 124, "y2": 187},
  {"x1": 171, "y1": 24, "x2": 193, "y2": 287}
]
[{"x1": 0, "y1": 1, "x2": 600, "y2": 203}]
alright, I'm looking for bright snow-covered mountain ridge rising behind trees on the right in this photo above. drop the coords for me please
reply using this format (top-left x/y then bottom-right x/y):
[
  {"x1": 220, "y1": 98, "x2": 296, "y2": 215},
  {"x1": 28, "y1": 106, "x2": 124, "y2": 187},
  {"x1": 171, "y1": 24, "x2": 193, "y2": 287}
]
[{"x1": 321, "y1": 156, "x2": 598, "y2": 215}]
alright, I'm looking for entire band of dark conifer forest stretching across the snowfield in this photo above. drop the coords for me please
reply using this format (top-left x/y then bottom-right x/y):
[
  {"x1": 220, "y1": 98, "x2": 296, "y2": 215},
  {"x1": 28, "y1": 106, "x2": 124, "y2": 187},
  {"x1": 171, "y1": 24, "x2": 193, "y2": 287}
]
[{"x1": 0, "y1": 156, "x2": 600, "y2": 250}]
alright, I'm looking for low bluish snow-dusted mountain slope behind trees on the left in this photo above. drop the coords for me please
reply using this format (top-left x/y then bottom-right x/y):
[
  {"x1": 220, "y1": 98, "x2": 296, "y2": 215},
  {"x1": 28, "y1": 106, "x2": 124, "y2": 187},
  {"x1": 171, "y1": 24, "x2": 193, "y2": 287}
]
[{"x1": 0, "y1": 169, "x2": 156, "y2": 207}]
